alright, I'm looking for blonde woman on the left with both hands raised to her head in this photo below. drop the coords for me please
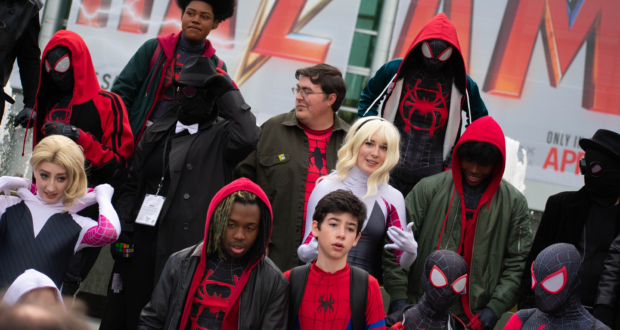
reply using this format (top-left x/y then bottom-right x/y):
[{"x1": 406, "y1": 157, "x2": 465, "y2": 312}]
[{"x1": 0, "y1": 135, "x2": 120, "y2": 289}]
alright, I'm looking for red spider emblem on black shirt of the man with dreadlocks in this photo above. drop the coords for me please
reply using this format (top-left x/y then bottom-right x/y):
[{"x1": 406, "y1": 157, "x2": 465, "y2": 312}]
[{"x1": 185, "y1": 260, "x2": 243, "y2": 330}]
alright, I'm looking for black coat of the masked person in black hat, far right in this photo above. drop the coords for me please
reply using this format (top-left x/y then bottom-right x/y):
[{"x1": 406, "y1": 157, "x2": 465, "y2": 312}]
[{"x1": 518, "y1": 188, "x2": 620, "y2": 309}]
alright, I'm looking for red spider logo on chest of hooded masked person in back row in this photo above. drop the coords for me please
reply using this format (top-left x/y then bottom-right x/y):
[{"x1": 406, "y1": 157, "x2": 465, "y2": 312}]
[{"x1": 400, "y1": 79, "x2": 450, "y2": 136}]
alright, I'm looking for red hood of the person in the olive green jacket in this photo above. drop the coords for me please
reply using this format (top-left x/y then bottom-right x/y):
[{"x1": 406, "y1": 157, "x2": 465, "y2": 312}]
[{"x1": 452, "y1": 116, "x2": 506, "y2": 214}]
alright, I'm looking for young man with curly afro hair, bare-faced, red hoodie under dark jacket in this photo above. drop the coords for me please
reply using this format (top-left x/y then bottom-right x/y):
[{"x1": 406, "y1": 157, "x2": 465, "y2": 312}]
[{"x1": 112, "y1": 0, "x2": 237, "y2": 145}]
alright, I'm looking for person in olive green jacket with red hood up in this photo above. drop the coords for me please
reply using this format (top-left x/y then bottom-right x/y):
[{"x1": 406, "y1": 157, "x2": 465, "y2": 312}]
[{"x1": 383, "y1": 117, "x2": 532, "y2": 330}]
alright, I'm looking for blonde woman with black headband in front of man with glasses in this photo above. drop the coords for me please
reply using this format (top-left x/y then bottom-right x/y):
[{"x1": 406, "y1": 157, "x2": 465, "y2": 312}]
[{"x1": 297, "y1": 117, "x2": 418, "y2": 277}]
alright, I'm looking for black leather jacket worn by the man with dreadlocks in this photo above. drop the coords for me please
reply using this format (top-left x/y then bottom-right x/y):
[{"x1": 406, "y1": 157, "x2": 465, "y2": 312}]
[{"x1": 138, "y1": 243, "x2": 288, "y2": 330}]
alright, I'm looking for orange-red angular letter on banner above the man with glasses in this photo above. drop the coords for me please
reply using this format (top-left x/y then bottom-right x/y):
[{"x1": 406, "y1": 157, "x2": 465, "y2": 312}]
[{"x1": 252, "y1": 0, "x2": 331, "y2": 63}]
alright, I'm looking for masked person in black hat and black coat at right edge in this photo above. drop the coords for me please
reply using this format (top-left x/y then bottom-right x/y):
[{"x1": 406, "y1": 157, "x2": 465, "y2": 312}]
[{"x1": 518, "y1": 129, "x2": 620, "y2": 312}]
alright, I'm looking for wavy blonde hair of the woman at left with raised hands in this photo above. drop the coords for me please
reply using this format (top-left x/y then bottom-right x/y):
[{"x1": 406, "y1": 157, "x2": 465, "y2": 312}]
[{"x1": 30, "y1": 135, "x2": 87, "y2": 209}]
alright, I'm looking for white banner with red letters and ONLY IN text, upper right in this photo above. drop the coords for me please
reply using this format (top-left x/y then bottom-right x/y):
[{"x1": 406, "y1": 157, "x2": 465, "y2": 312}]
[{"x1": 390, "y1": 0, "x2": 620, "y2": 188}]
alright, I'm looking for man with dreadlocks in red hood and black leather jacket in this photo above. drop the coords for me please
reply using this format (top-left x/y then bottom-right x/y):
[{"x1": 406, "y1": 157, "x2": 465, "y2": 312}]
[{"x1": 138, "y1": 178, "x2": 288, "y2": 330}]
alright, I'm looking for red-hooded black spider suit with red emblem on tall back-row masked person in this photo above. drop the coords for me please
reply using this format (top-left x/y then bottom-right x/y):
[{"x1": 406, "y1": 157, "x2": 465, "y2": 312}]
[{"x1": 383, "y1": 13, "x2": 466, "y2": 196}]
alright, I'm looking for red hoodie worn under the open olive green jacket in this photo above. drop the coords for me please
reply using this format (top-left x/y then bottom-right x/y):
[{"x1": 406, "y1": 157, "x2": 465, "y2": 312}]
[{"x1": 448, "y1": 116, "x2": 506, "y2": 319}]
